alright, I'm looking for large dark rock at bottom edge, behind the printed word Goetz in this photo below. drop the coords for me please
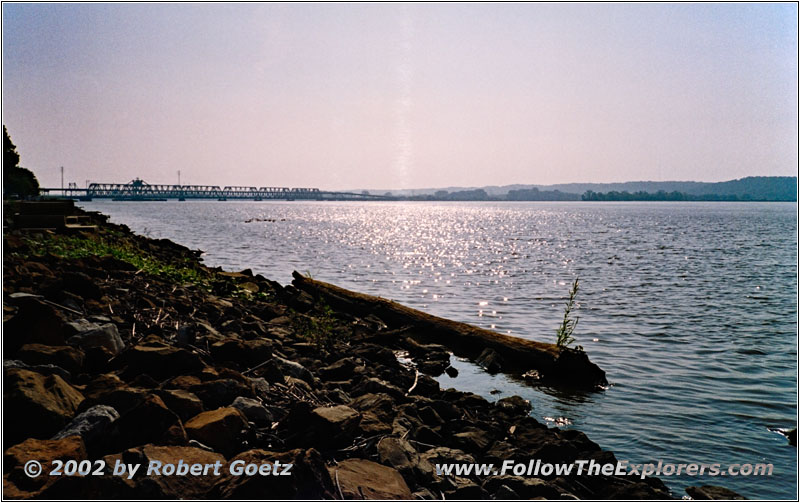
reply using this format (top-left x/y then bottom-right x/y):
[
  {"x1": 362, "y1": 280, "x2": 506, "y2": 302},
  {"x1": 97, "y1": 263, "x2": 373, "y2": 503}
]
[{"x1": 209, "y1": 449, "x2": 338, "y2": 501}]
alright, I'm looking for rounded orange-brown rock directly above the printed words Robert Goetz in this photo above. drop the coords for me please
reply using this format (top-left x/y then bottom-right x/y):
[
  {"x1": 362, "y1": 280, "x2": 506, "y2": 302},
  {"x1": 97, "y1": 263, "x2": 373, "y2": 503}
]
[{"x1": 185, "y1": 407, "x2": 249, "y2": 456}]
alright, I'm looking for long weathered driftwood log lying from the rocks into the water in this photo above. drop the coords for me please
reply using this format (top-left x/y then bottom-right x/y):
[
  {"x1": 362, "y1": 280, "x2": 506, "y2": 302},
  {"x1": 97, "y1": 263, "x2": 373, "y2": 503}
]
[{"x1": 292, "y1": 271, "x2": 608, "y2": 388}]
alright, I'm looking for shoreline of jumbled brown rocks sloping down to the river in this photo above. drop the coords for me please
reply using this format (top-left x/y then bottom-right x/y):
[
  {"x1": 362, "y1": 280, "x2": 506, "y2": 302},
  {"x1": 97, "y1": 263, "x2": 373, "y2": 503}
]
[{"x1": 3, "y1": 203, "x2": 730, "y2": 499}]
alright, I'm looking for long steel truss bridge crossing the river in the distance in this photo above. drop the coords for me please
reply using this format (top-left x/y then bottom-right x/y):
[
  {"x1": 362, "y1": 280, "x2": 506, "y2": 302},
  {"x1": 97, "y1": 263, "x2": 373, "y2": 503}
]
[{"x1": 40, "y1": 178, "x2": 394, "y2": 201}]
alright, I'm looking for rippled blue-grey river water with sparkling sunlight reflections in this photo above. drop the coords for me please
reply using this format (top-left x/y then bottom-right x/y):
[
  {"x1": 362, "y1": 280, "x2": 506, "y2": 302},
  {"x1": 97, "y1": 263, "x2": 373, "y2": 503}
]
[{"x1": 82, "y1": 201, "x2": 798, "y2": 499}]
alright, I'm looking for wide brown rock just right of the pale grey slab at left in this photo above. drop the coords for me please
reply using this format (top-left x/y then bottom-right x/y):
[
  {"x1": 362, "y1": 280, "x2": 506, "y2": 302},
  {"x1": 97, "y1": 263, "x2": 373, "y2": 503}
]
[{"x1": 117, "y1": 345, "x2": 205, "y2": 379}]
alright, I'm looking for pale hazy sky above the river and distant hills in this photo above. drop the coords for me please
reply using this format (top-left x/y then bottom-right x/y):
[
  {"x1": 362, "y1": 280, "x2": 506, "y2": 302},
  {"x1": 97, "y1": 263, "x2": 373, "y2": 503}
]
[{"x1": 2, "y1": 3, "x2": 798, "y2": 189}]
